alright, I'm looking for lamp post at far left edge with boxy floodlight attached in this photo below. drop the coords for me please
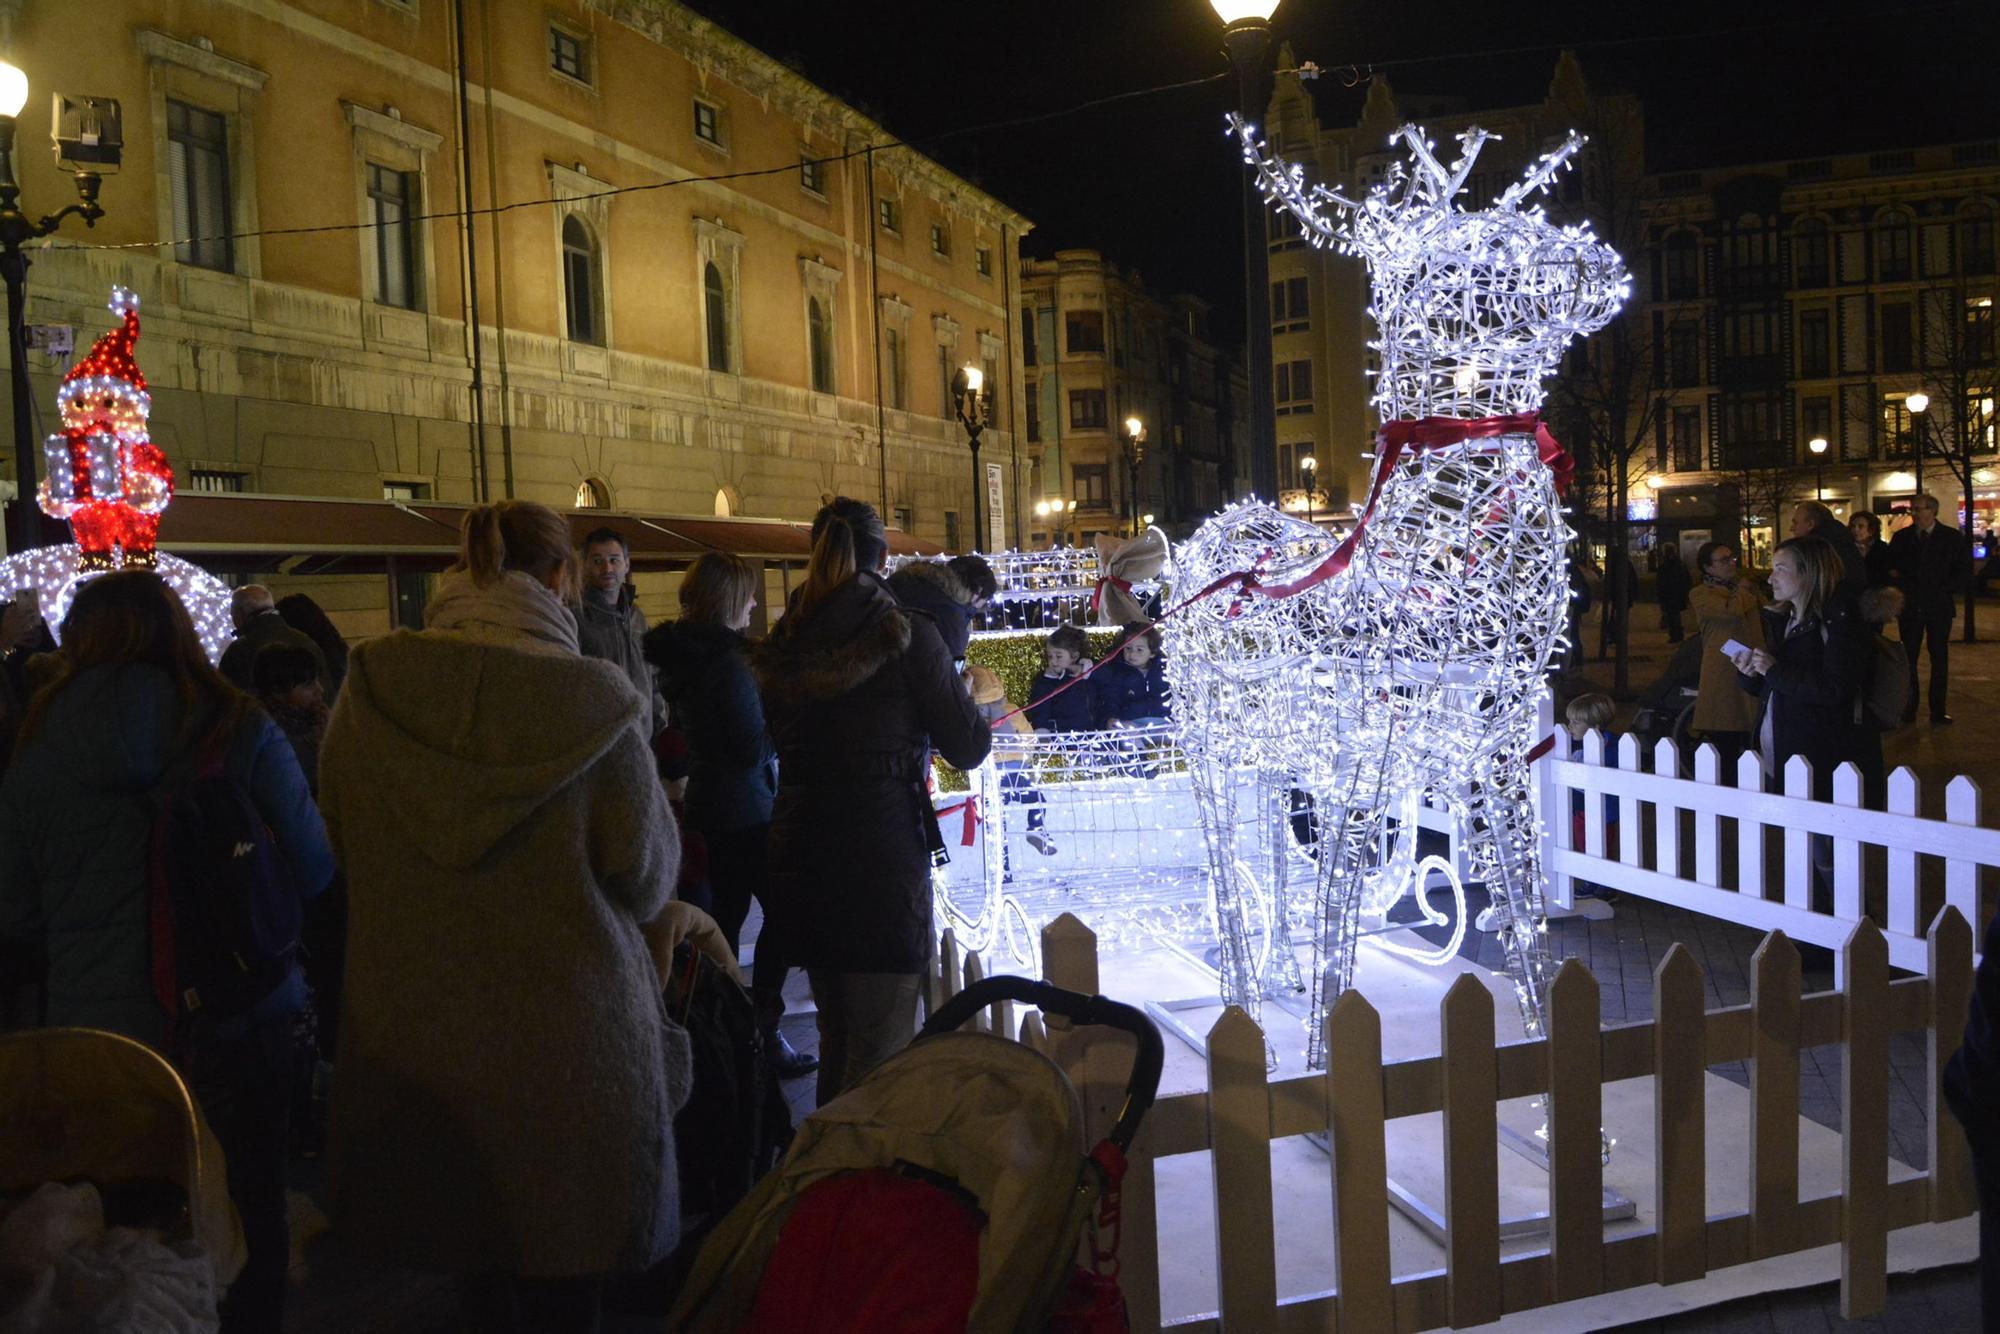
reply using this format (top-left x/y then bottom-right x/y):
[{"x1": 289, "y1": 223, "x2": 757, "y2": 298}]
[{"x1": 0, "y1": 60, "x2": 124, "y2": 546}]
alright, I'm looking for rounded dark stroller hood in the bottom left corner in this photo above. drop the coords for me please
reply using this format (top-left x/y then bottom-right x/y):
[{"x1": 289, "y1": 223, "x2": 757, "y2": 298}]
[{"x1": 0, "y1": 1028, "x2": 244, "y2": 1320}]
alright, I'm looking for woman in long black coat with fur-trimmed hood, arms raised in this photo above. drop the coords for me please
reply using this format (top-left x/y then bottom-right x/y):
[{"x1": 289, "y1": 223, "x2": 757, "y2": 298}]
[{"x1": 752, "y1": 496, "x2": 992, "y2": 1104}]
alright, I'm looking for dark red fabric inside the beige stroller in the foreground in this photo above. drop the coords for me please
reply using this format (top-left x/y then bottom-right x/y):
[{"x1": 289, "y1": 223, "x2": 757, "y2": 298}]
[{"x1": 740, "y1": 1168, "x2": 986, "y2": 1334}]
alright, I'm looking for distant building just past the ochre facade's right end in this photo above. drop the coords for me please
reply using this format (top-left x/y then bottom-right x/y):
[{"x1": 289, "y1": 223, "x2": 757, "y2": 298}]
[{"x1": 1020, "y1": 250, "x2": 1248, "y2": 546}]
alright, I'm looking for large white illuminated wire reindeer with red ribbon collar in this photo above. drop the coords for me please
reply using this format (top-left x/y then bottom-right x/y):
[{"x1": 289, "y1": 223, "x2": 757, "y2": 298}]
[{"x1": 1168, "y1": 118, "x2": 1630, "y2": 1066}]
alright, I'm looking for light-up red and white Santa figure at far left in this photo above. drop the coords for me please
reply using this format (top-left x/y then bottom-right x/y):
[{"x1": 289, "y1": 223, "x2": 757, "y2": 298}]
[{"x1": 38, "y1": 288, "x2": 174, "y2": 574}]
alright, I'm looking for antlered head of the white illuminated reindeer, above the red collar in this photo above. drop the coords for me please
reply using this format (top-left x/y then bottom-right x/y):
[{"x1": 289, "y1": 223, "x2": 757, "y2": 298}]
[{"x1": 1230, "y1": 116, "x2": 1632, "y2": 422}]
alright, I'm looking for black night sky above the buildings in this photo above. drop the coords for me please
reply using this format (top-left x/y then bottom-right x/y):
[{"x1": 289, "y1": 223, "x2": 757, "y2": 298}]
[{"x1": 692, "y1": 0, "x2": 2000, "y2": 336}]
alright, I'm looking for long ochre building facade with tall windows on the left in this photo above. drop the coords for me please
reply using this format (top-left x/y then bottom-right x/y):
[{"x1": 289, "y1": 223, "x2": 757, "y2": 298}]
[{"x1": 0, "y1": 0, "x2": 1032, "y2": 628}]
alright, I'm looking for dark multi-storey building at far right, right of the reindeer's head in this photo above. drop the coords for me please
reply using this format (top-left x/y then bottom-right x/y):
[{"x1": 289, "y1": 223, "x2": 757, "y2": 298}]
[{"x1": 1642, "y1": 140, "x2": 2000, "y2": 564}]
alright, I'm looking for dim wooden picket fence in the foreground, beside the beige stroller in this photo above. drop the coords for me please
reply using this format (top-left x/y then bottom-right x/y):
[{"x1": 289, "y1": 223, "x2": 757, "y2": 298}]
[{"x1": 930, "y1": 906, "x2": 1976, "y2": 1334}]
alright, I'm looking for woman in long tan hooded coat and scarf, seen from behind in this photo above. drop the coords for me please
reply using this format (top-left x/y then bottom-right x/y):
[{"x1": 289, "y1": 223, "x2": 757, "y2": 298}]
[{"x1": 320, "y1": 502, "x2": 688, "y2": 1330}]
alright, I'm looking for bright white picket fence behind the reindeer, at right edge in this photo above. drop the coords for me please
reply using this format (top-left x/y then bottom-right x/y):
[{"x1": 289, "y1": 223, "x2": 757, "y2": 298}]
[{"x1": 1536, "y1": 732, "x2": 2000, "y2": 972}]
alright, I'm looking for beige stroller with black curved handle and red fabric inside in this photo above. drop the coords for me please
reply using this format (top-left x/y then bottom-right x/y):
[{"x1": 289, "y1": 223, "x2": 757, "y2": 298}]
[{"x1": 668, "y1": 976, "x2": 1164, "y2": 1334}]
